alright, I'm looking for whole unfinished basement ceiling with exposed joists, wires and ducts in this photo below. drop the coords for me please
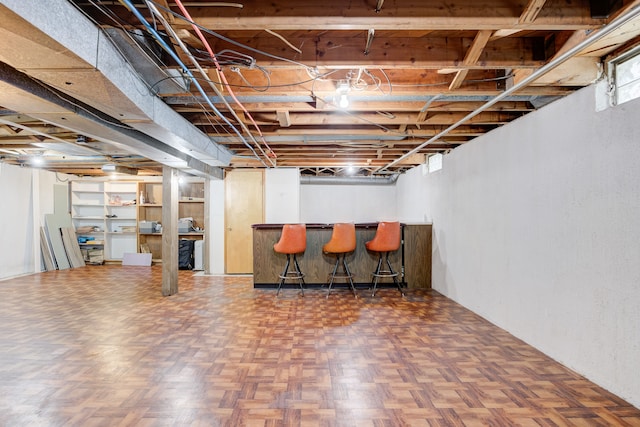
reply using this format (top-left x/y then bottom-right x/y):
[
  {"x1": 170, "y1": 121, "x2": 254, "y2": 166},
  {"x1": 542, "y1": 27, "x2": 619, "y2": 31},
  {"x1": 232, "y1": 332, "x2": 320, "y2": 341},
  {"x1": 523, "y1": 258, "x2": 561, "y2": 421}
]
[{"x1": 0, "y1": 0, "x2": 640, "y2": 177}]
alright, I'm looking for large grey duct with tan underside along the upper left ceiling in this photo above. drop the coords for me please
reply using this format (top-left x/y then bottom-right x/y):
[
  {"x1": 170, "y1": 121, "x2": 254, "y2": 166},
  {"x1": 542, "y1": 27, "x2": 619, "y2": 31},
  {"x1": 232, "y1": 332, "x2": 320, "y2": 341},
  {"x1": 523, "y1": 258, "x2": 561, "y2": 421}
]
[{"x1": 0, "y1": 0, "x2": 232, "y2": 176}]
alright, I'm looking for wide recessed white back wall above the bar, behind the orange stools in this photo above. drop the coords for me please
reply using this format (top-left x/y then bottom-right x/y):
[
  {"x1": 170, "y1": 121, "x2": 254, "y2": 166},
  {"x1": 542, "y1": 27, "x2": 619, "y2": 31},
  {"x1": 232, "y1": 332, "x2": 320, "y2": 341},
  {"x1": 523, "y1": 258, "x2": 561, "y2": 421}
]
[{"x1": 300, "y1": 184, "x2": 397, "y2": 224}]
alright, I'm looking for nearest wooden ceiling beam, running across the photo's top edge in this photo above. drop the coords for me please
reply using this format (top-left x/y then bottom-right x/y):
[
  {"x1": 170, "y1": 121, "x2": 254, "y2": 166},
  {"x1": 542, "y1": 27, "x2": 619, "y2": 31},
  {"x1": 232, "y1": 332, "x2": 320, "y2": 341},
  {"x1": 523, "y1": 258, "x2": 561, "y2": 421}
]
[{"x1": 182, "y1": 0, "x2": 604, "y2": 31}]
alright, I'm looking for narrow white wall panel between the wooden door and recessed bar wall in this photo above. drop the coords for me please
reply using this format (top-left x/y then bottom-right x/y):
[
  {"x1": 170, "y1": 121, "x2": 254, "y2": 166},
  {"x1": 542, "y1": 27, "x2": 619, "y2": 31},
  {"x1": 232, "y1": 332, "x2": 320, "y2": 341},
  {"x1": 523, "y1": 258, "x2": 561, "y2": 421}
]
[{"x1": 264, "y1": 168, "x2": 300, "y2": 224}]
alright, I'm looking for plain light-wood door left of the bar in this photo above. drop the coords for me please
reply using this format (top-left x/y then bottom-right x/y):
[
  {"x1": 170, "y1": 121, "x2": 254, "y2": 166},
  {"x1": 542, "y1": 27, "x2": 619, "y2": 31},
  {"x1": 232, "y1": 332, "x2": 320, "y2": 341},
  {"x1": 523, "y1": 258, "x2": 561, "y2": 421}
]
[{"x1": 224, "y1": 169, "x2": 264, "y2": 274}]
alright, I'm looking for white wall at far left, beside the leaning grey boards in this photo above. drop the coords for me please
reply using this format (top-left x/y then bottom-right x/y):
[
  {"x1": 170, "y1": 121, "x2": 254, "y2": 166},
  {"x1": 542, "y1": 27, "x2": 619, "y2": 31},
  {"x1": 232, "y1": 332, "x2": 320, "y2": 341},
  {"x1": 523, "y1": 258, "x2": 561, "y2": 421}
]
[{"x1": 0, "y1": 163, "x2": 61, "y2": 279}]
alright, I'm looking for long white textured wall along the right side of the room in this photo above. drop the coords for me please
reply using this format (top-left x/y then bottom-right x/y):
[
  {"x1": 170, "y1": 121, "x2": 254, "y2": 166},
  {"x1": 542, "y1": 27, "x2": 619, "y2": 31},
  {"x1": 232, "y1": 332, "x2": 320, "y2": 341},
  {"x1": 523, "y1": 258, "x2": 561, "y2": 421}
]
[{"x1": 398, "y1": 83, "x2": 640, "y2": 407}]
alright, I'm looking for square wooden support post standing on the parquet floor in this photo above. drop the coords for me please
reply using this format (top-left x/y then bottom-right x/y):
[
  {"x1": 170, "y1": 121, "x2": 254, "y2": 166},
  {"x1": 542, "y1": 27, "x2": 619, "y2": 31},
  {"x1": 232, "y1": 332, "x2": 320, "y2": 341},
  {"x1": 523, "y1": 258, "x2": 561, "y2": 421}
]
[{"x1": 162, "y1": 166, "x2": 178, "y2": 297}]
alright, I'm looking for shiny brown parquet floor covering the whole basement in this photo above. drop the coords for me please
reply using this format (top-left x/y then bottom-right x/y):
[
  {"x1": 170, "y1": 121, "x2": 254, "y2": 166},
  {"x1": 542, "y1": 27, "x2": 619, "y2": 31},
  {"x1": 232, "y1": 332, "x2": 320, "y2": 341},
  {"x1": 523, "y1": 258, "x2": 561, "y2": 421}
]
[{"x1": 0, "y1": 266, "x2": 640, "y2": 427}]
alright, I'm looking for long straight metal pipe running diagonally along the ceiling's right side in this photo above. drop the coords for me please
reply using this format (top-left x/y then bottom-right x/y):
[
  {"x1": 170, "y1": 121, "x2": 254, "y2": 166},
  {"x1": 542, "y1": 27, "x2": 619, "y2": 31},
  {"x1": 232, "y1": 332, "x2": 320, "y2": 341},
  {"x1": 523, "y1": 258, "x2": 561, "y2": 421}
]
[{"x1": 376, "y1": 6, "x2": 640, "y2": 173}]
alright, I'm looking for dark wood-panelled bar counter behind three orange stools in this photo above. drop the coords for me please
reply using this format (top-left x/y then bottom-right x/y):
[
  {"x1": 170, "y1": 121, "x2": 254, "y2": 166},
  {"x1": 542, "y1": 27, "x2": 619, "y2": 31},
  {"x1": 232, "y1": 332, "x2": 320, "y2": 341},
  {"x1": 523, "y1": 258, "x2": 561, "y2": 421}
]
[{"x1": 252, "y1": 223, "x2": 431, "y2": 289}]
